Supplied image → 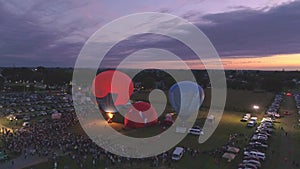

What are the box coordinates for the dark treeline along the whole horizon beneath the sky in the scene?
[0,67,300,92]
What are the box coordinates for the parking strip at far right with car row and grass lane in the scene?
[238,94,300,169]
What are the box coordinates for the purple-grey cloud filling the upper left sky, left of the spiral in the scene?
[0,0,99,66]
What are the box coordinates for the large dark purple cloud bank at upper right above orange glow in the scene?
[198,1,300,57]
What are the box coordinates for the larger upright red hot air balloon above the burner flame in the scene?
[92,70,133,106]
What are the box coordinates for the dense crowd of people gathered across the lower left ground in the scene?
[1,106,204,168]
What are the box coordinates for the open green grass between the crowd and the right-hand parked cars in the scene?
[12,90,282,169]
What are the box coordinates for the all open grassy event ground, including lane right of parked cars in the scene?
[2,91,300,169]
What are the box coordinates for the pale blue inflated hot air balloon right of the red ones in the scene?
[169,81,204,118]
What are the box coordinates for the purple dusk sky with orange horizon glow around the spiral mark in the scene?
[0,0,300,70]
